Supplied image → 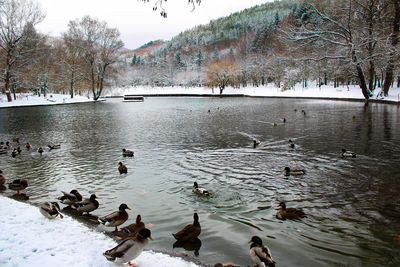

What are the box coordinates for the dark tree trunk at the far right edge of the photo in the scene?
[383,0,400,96]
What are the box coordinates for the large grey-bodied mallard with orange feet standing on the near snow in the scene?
[103,228,153,266]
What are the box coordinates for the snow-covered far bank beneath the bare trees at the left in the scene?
[0,94,94,108]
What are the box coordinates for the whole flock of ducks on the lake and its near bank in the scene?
[0,124,356,267]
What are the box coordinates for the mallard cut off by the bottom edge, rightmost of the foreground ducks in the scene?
[249,236,275,267]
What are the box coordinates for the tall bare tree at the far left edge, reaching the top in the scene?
[0,0,44,101]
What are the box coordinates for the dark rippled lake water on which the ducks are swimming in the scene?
[0,98,400,266]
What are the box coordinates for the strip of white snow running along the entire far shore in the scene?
[0,83,400,108]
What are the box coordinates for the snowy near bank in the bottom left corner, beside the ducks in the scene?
[0,196,197,267]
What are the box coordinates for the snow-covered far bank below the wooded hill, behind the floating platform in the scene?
[106,84,400,102]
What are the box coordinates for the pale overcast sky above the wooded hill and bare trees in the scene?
[37,0,271,49]
